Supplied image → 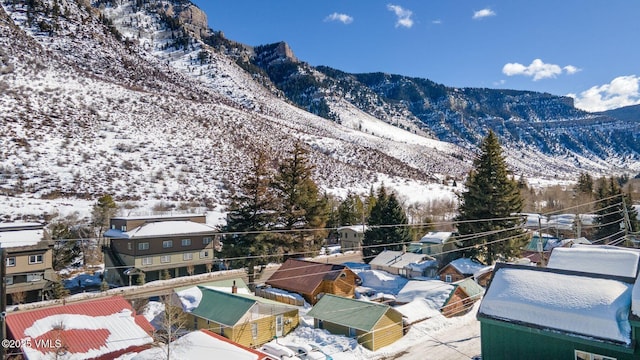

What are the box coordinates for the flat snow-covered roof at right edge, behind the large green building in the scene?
[547,245,640,278]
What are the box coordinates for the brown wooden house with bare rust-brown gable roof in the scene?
[265,259,360,304]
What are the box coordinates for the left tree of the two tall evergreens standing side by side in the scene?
[223,151,277,282]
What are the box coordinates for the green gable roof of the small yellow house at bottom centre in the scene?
[307,294,396,331]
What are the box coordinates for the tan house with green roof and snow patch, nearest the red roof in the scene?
[176,286,300,347]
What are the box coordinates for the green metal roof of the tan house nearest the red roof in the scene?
[191,286,256,326]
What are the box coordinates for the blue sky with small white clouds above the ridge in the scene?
[193,0,640,111]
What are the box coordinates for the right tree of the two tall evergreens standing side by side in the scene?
[272,143,329,253]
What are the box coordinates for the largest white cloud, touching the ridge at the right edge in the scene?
[567,75,640,111]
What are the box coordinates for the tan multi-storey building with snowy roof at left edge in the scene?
[0,222,58,304]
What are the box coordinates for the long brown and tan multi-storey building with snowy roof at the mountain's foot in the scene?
[104,214,221,283]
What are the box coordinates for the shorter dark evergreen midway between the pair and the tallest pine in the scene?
[362,186,411,263]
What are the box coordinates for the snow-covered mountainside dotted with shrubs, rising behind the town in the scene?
[0,0,640,214]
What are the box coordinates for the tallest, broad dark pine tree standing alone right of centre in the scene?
[456,131,525,263]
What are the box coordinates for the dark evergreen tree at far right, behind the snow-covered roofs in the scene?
[595,177,638,244]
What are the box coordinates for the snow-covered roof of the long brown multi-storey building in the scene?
[104,221,216,239]
